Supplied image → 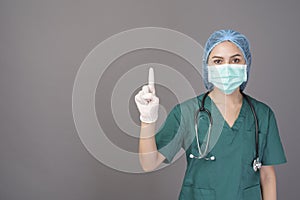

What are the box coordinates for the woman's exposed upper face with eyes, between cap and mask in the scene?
[207,41,246,66]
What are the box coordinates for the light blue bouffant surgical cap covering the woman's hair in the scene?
[202,30,251,91]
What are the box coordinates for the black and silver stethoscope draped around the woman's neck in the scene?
[190,91,262,172]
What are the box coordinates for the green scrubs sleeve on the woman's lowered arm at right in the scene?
[262,110,287,165]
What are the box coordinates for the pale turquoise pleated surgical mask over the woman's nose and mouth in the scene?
[207,64,247,94]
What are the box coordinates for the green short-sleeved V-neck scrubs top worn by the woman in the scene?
[155,94,286,200]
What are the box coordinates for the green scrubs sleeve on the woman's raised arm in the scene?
[155,104,184,163]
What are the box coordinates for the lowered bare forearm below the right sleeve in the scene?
[260,166,277,200]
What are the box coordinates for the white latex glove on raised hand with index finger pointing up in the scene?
[135,68,159,123]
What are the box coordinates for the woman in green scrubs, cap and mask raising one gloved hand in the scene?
[135,30,286,200]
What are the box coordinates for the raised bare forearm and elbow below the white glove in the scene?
[139,122,165,171]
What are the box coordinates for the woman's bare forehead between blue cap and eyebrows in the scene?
[209,41,243,58]
